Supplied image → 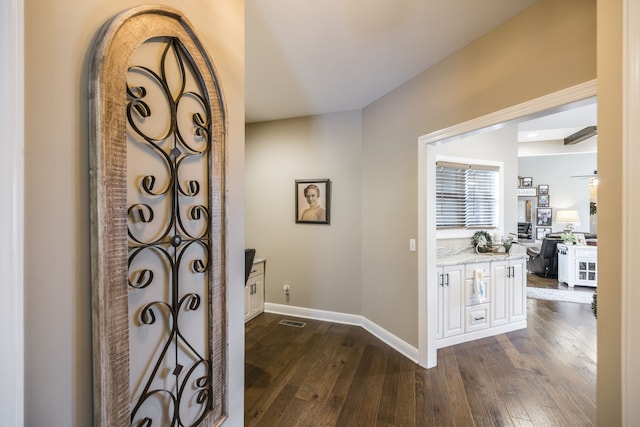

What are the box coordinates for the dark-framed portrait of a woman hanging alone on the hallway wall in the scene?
[295,179,331,224]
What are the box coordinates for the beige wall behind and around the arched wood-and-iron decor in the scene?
[24,0,244,426]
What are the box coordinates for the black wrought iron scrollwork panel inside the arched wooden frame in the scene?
[126,37,212,427]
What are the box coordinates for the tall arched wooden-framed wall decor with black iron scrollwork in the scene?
[89,6,228,427]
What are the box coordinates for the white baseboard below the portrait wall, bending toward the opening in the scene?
[264,302,418,363]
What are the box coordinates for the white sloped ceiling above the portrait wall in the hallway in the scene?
[245,0,536,123]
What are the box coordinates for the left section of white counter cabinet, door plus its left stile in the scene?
[437,265,465,338]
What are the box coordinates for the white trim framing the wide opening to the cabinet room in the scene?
[418,80,597,368]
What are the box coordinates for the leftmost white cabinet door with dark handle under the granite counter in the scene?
[442,265,465,338]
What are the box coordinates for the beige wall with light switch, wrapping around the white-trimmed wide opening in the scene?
[362,0,596,346]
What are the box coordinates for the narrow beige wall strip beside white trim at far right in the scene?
[598,0,624,426]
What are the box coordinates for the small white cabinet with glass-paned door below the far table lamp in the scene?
[558,244,598,287]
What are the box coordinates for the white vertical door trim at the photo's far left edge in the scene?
[0,0,24,427]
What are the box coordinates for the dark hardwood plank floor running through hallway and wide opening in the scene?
[245,299,596,427]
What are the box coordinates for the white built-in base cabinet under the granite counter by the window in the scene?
[436,255,527,348]
